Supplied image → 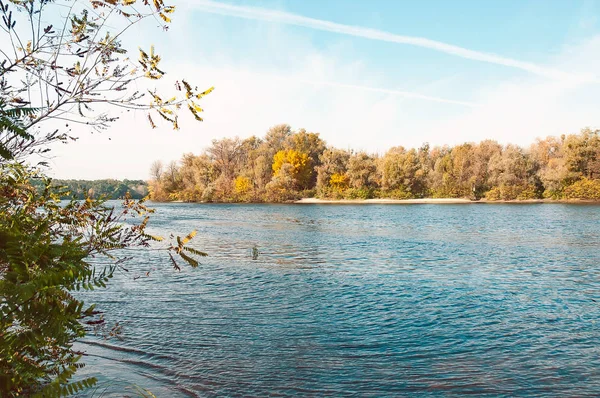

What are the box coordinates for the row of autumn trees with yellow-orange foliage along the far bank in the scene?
[149,124,600,202]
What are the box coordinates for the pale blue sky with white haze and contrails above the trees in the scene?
[50,0,600,179]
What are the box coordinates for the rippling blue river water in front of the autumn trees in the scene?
[80,204,600,397]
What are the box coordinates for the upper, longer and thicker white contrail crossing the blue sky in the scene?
[190,0,600,83]
